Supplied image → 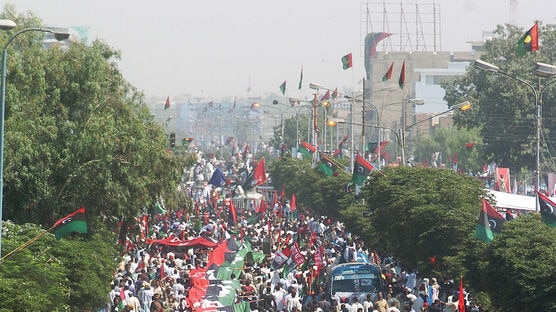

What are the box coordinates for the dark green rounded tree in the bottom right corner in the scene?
[474,213,556,312]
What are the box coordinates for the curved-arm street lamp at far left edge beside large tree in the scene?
[0,20,69,257]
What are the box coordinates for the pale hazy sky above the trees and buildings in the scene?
[7,0,556,98]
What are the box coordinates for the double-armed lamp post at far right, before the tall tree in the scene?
[473,60,556,212]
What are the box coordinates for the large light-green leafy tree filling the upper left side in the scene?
[0,8,186,234]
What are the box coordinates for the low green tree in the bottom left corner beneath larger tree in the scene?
[0,221,118,312]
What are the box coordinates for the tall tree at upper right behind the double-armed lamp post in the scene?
[444,21,556,177]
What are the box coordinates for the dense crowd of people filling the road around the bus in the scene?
[106,154,481,312]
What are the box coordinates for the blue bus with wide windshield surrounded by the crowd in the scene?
[327,262,385,304]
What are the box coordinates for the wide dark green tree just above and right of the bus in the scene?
[363,167,485,277]
